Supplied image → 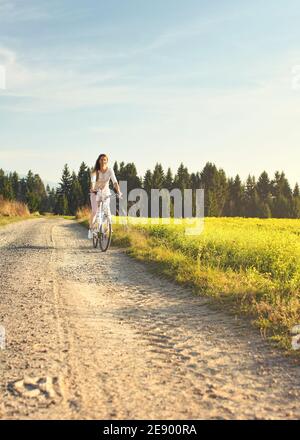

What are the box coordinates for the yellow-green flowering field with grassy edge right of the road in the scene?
[113,218,300,348]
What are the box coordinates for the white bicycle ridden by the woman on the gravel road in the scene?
[91,190,121,252]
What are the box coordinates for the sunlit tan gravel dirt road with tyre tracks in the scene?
[0,219,300,419]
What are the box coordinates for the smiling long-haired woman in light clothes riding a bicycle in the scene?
[88,154,122,238]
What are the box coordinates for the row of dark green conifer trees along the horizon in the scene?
[0,162,300,218]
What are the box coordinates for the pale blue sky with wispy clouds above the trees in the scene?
[0,0,300,185]
